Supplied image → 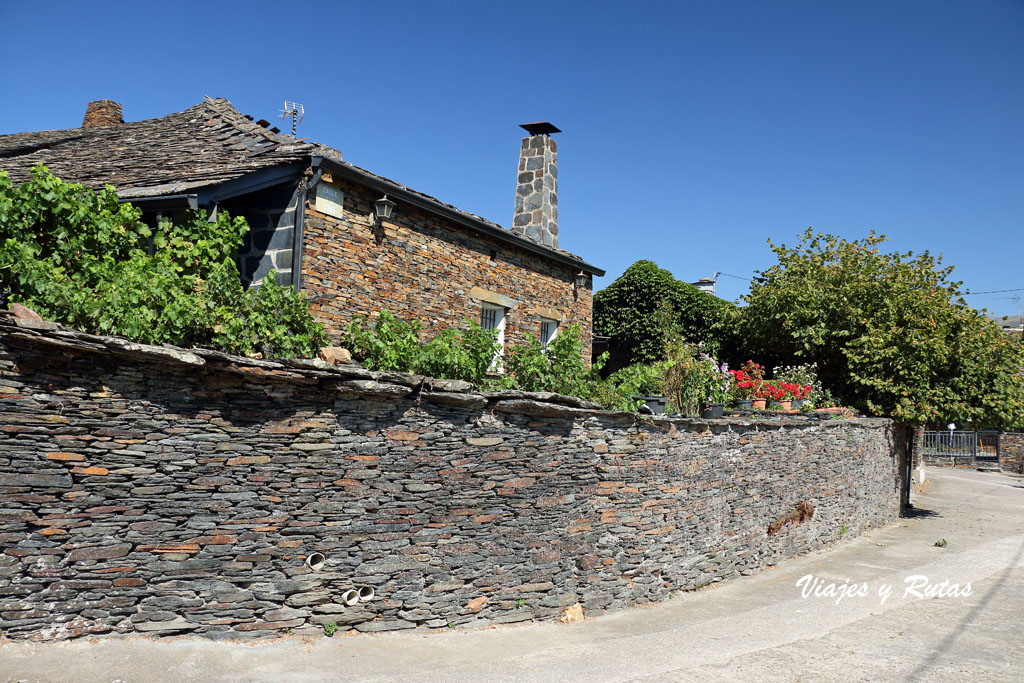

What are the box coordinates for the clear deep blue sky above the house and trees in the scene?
[0,0,1024,313]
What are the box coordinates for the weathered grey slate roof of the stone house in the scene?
[0,97,604,275]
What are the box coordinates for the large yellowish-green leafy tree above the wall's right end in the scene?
[740,228,1024,426]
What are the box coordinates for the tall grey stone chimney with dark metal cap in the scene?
[512,122,561,249]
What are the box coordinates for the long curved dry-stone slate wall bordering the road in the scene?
[0,314,906,639]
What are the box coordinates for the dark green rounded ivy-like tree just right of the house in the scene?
[594,261,736,370]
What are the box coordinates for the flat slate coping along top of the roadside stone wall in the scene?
[0,310,892,431]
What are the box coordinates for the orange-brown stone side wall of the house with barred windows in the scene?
[302,180,593,360]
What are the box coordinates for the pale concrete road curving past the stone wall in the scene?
[0,469,1024,683]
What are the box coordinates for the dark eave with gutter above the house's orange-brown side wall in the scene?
[312,156,605,278]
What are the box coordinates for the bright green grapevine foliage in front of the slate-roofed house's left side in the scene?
[0,166,327,356]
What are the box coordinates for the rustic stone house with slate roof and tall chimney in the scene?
[0,97,604,359]
